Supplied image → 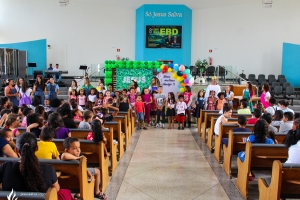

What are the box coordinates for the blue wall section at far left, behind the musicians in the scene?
[0,39,47,75]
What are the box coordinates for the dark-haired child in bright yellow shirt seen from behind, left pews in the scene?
[35,126,60,160]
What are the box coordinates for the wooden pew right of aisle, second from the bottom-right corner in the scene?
[236,142,288,199]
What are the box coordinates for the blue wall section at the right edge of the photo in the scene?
[281,43,300,87]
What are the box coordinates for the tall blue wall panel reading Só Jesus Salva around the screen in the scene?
[135,4,192,66]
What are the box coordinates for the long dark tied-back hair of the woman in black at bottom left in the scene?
[16,133,46,192]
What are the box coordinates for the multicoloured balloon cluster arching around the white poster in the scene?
[156,63,194,93]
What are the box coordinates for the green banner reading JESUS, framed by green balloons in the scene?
[116,68,153,90]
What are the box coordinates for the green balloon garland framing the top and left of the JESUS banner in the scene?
[105,60,162,85]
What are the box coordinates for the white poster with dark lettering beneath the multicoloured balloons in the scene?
[156,72,179,98]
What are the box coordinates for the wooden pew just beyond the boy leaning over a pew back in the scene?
[53,139,109,192]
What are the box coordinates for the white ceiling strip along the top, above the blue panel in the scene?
[92,0,262,10]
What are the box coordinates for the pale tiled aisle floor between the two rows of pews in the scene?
[112,128,229,200]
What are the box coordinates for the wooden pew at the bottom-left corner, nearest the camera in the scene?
[0,187,58,200]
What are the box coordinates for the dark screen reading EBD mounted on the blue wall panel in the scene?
[146,26,182,48]
